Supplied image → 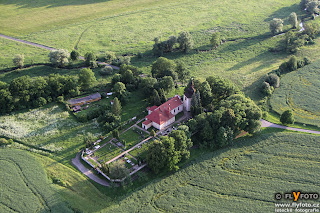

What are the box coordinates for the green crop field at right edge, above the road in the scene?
[270,61,320,127]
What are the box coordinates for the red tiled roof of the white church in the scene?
[146,96,183,125]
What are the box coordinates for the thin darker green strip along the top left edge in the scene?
[1,0,110,8]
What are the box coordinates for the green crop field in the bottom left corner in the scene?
[0,148,73,212]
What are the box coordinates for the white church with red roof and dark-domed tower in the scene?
[142,83,195,130]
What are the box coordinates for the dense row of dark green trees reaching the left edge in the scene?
[0,68,96,113]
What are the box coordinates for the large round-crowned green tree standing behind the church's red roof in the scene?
[151,57,176,78]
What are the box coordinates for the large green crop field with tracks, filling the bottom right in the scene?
[106,133,320,212]
